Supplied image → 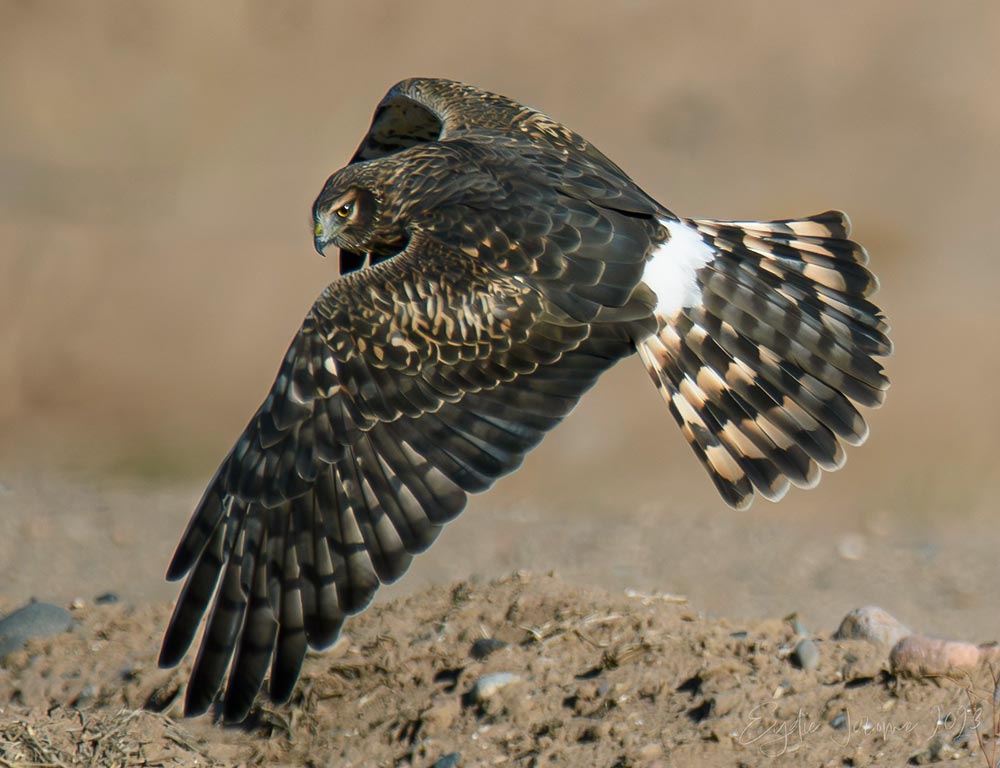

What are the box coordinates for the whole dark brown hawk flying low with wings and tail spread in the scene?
[160,79,891,721]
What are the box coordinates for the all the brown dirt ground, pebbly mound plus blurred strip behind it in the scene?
[0,474,996,768]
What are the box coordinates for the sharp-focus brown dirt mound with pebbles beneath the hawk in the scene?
[0,574,993,768]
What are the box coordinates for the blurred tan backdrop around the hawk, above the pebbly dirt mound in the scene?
[0,0,1000,639]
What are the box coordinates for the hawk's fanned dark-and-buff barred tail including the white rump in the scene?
[639,211,892,509]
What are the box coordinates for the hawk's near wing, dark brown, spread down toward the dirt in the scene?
[160,220,654,720]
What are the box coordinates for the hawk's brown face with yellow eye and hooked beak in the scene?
[313,166,379,254]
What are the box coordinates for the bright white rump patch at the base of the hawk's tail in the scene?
[643,220,717,318]
